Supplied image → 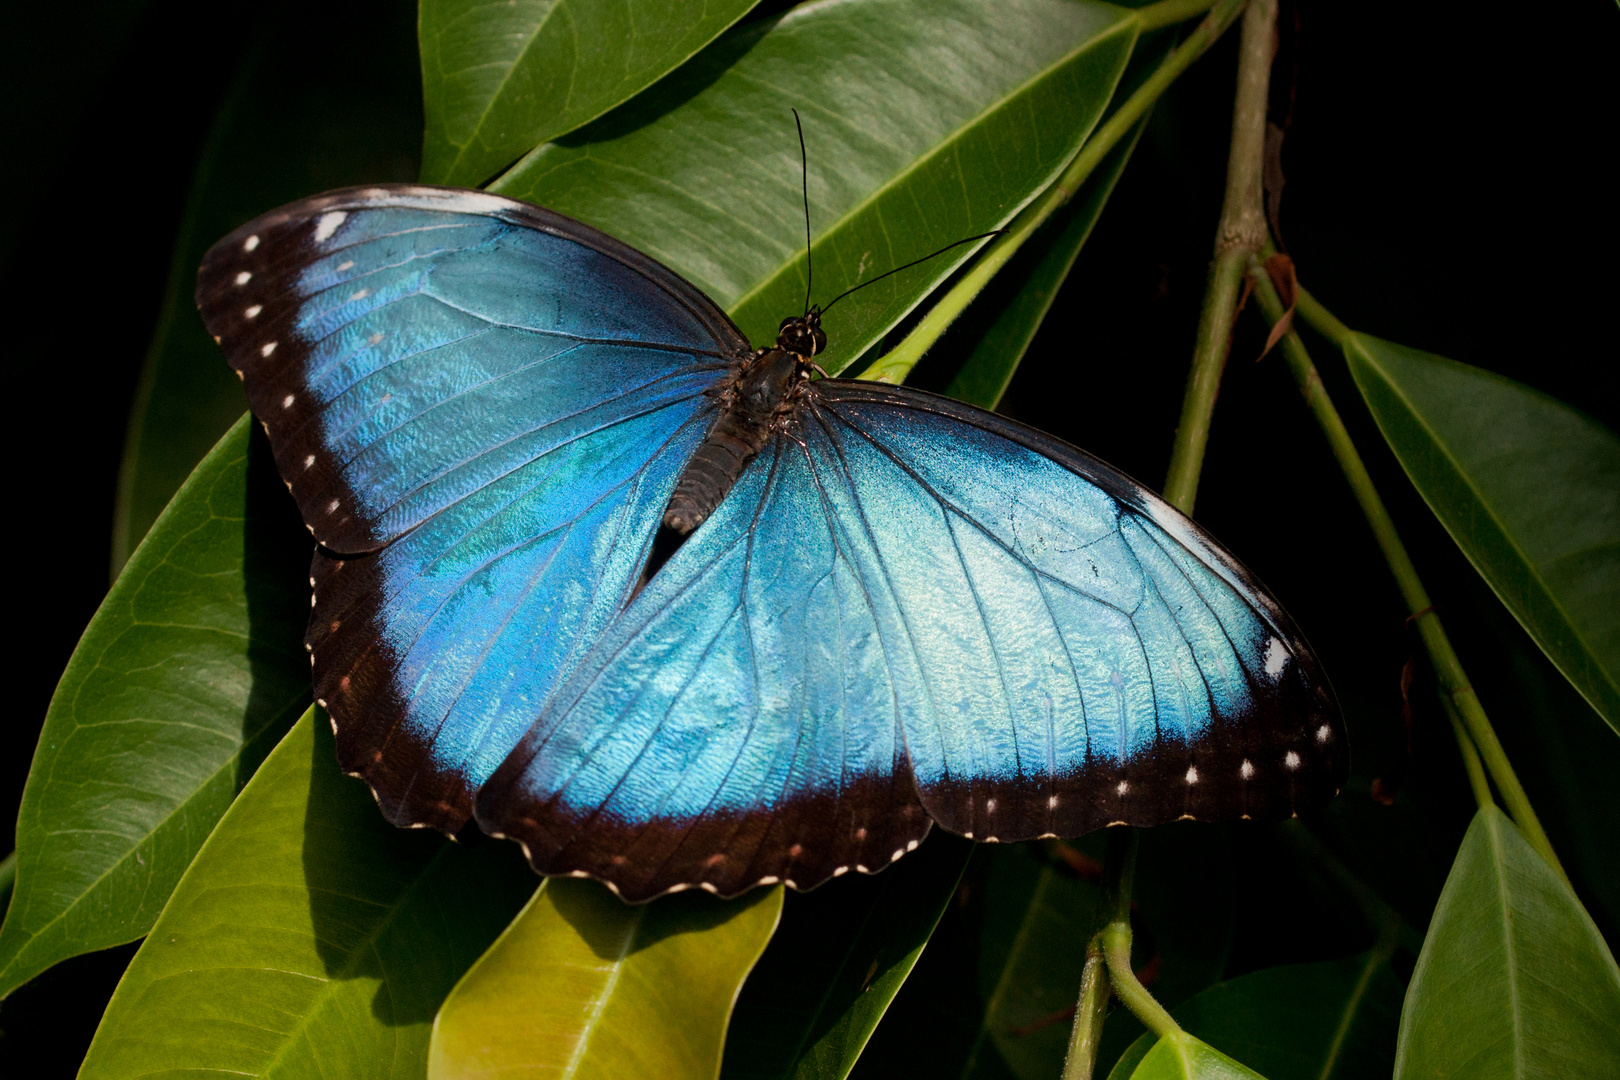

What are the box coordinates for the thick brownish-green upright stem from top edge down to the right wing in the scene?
[1165,0,1277,517]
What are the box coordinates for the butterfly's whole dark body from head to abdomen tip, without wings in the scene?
[664,309,826,536]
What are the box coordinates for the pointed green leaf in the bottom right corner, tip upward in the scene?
[1395,806,1620,1080]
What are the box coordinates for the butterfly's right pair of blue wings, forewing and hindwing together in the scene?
[478,381,1346,899]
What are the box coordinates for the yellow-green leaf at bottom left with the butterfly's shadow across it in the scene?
[79,709,535,1080]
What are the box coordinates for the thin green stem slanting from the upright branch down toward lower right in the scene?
[1252,266,1568,881]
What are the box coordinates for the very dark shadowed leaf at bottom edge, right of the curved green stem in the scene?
[1108,952,1401,1080]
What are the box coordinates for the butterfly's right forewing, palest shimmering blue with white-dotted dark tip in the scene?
[821,381,1348,840]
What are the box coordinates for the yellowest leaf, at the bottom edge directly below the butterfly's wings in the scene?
[428,878,782,1080]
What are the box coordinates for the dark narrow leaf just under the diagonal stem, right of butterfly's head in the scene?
[941,111,1147,410]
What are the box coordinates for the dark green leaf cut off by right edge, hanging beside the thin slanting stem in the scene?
[1345,334,1620,732]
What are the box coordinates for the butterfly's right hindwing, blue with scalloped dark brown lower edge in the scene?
[478,440,928,900]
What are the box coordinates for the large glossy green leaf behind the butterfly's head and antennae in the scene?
[492,0,1137,371]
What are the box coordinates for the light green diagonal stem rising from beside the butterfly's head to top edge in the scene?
[859,0,1246,384]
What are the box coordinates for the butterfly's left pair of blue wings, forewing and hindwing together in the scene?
[198,186,748,832]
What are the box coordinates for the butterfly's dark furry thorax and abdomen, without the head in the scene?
[664,348,805,536]
